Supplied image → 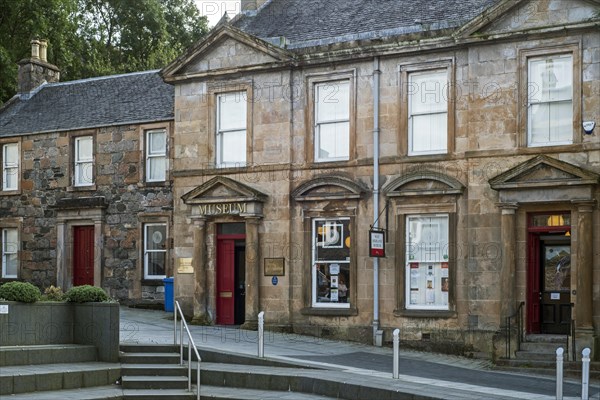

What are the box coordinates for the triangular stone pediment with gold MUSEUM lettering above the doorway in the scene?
[181,176,267,217]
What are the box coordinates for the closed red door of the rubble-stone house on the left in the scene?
[73,226,94,286]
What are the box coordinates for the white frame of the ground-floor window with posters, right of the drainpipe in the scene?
[404,213,453,311]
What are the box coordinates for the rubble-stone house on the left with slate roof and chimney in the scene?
[0,40,174,303]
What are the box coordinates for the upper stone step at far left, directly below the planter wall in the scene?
[0,344,97,367]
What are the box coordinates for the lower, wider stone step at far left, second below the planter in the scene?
[0,361,121,396]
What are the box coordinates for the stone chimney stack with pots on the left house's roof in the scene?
[18,39,60,97]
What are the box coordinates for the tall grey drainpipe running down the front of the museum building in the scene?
[373,57,382,346]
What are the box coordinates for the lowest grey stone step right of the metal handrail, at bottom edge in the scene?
[200,385,336,400]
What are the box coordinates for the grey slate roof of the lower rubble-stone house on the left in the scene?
[0,70,175,137]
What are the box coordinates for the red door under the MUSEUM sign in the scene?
[217,239,235,325]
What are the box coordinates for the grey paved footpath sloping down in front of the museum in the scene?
[120,307,600,400]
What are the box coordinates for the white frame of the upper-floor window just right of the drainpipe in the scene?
[408,68,450,156]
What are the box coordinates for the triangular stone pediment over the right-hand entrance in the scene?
[489,155,600,203]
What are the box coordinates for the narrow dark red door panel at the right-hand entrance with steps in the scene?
[527,233,541,333]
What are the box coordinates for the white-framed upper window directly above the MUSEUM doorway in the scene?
[217,91,247,167]
